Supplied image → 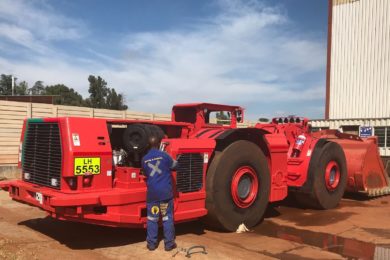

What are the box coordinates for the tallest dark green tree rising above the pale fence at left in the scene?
[87,75,109,108]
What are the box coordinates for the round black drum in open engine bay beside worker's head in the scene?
[123,124,151,153]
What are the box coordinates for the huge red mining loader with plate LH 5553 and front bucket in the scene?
[0,103,389,231]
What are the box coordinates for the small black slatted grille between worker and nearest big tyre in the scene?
[176,153,203,193]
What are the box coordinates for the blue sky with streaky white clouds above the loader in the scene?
[0,0,327,119]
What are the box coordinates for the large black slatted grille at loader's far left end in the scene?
[23,122,62,189]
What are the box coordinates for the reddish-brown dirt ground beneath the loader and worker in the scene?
[0,191,390,260]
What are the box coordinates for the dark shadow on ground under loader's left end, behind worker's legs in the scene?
[19,217,204,249]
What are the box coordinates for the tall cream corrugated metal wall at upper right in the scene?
[329,0,390,119]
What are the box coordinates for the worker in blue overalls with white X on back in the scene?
[142,136,176,251]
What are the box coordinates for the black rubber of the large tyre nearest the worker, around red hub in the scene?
[205,141,270,231]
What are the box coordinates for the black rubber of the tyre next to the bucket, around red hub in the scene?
[293,142,347,209]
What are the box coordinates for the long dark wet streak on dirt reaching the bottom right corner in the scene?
[254,221,390,259]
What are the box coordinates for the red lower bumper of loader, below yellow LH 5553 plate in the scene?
[0,180,207,227]
